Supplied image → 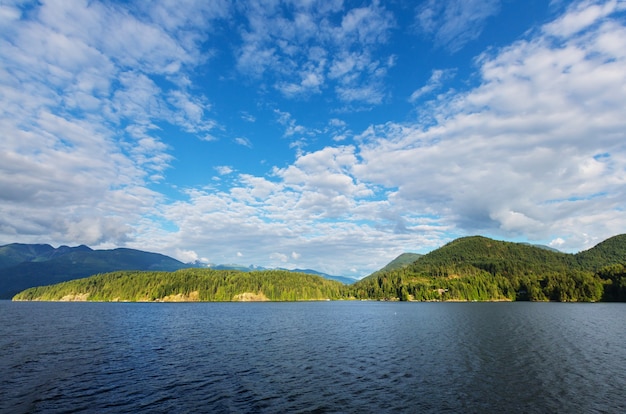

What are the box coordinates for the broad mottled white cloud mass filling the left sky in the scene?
[0,0,225,245]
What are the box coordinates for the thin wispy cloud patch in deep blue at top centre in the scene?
[236,1,394,104]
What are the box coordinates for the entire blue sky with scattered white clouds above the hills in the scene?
[0,0,626,278]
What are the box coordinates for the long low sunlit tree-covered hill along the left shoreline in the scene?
[13,268,344,301]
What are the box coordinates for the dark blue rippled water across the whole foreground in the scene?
[0,301,626,413]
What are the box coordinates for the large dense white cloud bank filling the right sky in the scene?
[354,0,626,247]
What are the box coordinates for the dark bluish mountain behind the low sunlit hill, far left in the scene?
[0,243,188,299]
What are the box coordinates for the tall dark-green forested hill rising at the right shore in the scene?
[353,235,626,301]
